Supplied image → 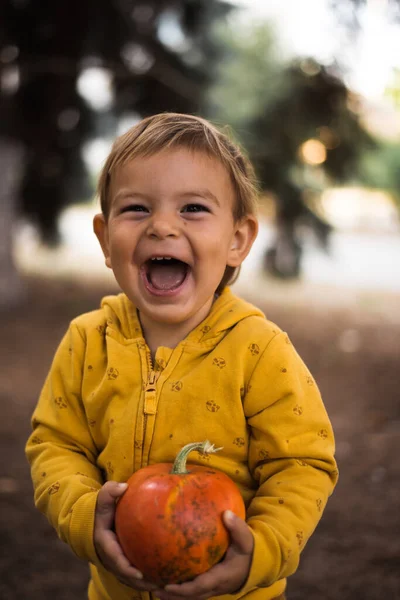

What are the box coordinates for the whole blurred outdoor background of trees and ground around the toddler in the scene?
[0,0,400,600]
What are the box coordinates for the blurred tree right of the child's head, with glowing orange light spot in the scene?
[208,24,374,278]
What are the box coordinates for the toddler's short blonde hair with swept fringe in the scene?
[97,113,258,293]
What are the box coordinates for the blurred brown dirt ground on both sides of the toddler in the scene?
[0,278,400,600]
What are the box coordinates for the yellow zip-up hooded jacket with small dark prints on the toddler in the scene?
[26,288,337,600]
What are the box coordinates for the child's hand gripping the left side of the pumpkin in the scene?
[93,481,161,591]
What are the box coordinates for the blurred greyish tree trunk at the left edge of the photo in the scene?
[0,138,24,309]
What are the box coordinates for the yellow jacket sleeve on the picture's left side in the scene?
[26,323,102,563]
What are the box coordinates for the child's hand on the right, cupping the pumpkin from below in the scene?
[155,510,254,600]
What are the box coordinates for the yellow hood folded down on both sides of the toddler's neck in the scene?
[101,287,265,342]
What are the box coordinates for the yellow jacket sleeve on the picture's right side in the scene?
[241,332,338,593]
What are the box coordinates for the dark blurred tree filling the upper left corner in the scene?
[0,0,231,303]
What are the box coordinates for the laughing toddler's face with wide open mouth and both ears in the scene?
[94,148,257,330]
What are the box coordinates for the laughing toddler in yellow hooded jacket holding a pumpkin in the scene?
[26,113,337,600]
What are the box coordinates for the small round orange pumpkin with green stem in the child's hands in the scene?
[115,441,245,586]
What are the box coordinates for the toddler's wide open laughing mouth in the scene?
[144,256,190,293]
